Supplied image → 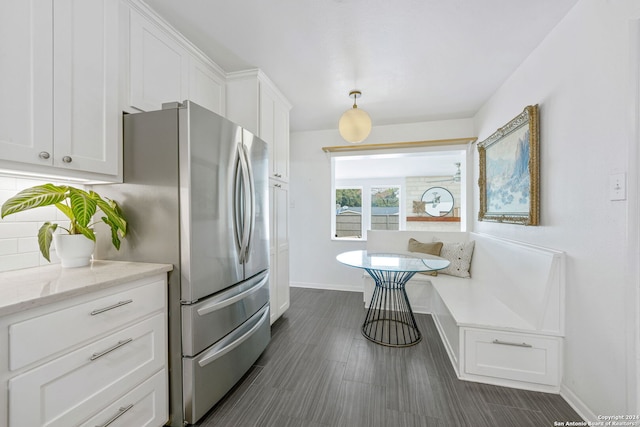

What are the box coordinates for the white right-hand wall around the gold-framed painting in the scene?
[474,0,640,421]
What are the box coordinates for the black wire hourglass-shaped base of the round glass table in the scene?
[362,269,422,347]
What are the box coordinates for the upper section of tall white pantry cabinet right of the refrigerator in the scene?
[227,70,291,181]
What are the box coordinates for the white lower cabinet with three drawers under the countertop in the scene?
[0,275,168,427]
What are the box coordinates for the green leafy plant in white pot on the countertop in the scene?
[0,184,127,267]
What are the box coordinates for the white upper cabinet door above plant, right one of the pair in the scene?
[53,0,121,175]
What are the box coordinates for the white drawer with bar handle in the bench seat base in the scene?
[464,329,561,385]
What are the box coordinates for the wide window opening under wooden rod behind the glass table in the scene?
[331,150,468,240]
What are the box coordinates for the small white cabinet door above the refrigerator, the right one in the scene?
[189,57,225,116]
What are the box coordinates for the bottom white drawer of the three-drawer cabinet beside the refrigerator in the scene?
[80,369,169,427]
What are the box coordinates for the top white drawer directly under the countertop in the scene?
[9,280,166,371]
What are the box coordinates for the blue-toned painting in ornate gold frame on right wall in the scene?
[478,105,540,225]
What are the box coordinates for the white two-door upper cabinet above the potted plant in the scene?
[0,0,121,181]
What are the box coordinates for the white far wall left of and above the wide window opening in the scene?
[289,118,474,290]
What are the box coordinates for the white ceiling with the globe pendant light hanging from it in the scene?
[146,0,578,131]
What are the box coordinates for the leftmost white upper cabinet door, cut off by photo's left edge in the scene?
[0,0,53,165]
